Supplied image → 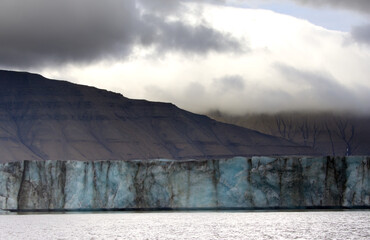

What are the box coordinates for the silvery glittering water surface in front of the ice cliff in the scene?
[0,211,370,240]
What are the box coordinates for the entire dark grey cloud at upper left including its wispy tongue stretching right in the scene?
[0,0,239,67]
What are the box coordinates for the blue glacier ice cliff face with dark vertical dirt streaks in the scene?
[0,157,370,210]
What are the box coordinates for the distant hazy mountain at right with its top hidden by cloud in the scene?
[207,111,370,156]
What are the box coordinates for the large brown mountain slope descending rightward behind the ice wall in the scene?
[0,71,313,162]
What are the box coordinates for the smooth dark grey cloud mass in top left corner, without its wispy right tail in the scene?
[0,0,139,66]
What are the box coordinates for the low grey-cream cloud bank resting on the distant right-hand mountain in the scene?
[146,63,370,115]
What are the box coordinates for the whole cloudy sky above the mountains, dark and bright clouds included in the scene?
[0,0,370,115]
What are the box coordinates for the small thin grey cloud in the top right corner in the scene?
[292,0,370,14]
